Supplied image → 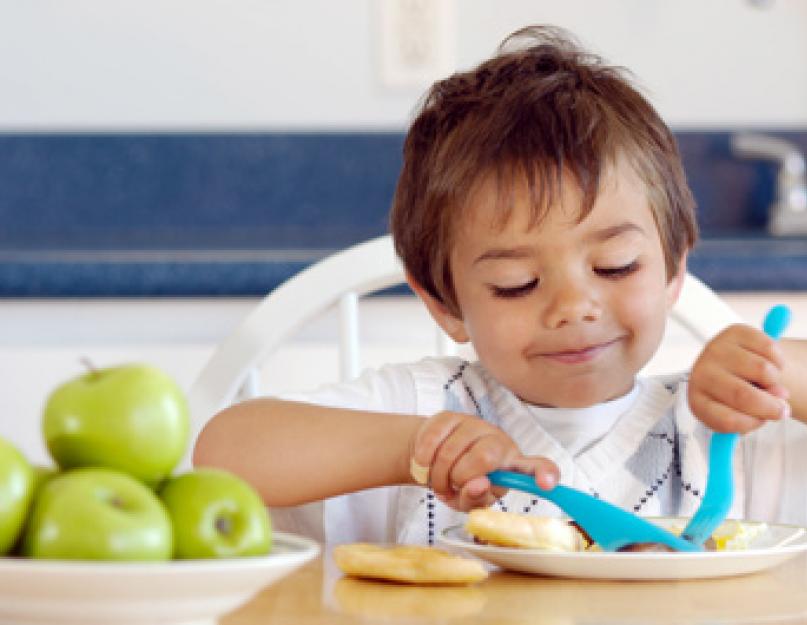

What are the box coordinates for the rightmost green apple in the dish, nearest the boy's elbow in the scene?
[160,468,272,558]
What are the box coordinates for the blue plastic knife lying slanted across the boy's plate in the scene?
[488,471,702,551]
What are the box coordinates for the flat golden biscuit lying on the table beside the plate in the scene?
[333,543,488,584]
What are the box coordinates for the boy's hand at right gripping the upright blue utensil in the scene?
[688,324,790,433]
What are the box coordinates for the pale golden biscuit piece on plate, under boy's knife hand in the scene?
[465,508,589,551]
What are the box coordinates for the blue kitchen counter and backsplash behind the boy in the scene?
[0,131,807,297]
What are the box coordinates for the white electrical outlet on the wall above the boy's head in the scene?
[375,0,457,87]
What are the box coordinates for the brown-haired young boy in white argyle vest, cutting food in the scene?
[194,27,807,544]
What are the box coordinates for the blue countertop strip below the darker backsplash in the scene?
[0,232,807,297]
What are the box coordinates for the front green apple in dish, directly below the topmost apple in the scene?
[22,467,173,560]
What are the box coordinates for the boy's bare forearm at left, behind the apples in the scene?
[193,398,423,506]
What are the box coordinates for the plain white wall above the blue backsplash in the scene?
[0,0,807,131]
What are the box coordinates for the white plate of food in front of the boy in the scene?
[440,519,807,580]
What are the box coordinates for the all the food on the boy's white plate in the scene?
[465,508,767,552]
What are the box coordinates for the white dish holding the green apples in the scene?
[0,532,319,625]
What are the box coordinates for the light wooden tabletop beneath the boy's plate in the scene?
[221,550,807,625]
